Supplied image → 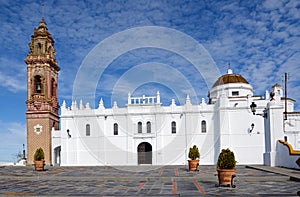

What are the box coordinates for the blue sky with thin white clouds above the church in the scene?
[0,0,300,161]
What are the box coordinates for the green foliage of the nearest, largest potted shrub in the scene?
[217,148,236,169]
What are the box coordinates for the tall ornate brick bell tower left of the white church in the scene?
[25,17,60,165]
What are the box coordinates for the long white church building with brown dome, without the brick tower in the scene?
[52,69,300,167]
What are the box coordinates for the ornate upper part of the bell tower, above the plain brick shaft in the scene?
[25,17,60,112]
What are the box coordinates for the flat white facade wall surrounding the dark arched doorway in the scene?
[61,91,265,165]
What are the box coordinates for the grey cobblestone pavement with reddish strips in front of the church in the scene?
[0,166,300,196]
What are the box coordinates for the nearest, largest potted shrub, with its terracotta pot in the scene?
[217,148,236,187]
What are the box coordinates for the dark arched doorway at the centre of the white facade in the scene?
[137,142,152,164]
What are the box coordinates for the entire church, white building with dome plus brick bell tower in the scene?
[25,19,300,168]
